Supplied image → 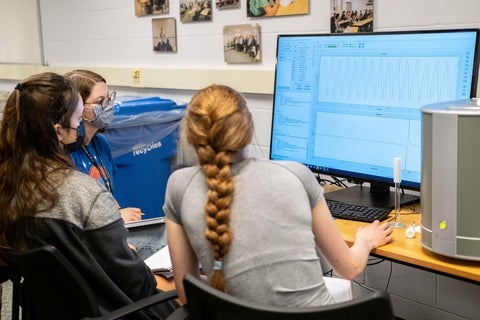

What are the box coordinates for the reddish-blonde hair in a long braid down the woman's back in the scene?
[184,85,253,292]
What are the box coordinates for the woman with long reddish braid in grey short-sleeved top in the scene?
[164,85,392,306]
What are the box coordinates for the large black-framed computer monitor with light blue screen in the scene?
[270,29,479,208]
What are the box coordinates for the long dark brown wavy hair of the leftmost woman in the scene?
[0,72,79,260]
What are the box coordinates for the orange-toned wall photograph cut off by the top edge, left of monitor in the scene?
[247,0,309,17]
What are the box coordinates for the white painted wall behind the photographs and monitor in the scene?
[0,0,480,157]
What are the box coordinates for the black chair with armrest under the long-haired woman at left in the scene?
[4,245,178,320]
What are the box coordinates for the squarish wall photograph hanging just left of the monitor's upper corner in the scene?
[223,23,261,63]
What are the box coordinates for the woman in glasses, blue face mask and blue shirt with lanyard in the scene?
[65,70,166,259]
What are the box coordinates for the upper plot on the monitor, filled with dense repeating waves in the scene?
[317,56,459,107]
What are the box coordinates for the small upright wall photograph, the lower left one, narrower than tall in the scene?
[152,18,177,52]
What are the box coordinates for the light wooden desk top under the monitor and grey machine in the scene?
[335,208,480,282]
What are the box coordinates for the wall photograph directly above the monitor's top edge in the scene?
[330,0,373,33]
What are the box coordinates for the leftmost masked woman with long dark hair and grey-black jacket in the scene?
[0,73,178,319]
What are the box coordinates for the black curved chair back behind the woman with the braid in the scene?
[183,275,394,320]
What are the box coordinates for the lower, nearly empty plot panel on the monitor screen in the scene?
[313,112,421,172]
